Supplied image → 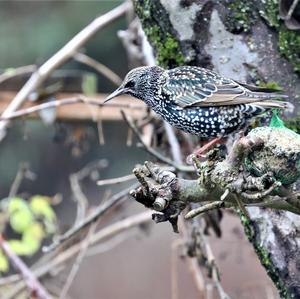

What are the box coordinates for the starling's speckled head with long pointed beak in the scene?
[105,66,164,107]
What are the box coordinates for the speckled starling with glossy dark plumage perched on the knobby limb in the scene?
[106,66,287,138]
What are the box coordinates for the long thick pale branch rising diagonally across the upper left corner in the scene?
[0,2,130,141]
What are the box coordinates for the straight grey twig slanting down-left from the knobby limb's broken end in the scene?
[44,183,139,252]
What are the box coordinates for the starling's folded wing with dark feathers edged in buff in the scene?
[163,67,284,108]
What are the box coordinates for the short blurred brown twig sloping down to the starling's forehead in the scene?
[73,53,122,86]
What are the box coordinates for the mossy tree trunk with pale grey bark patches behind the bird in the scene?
[134,0,300,298]
